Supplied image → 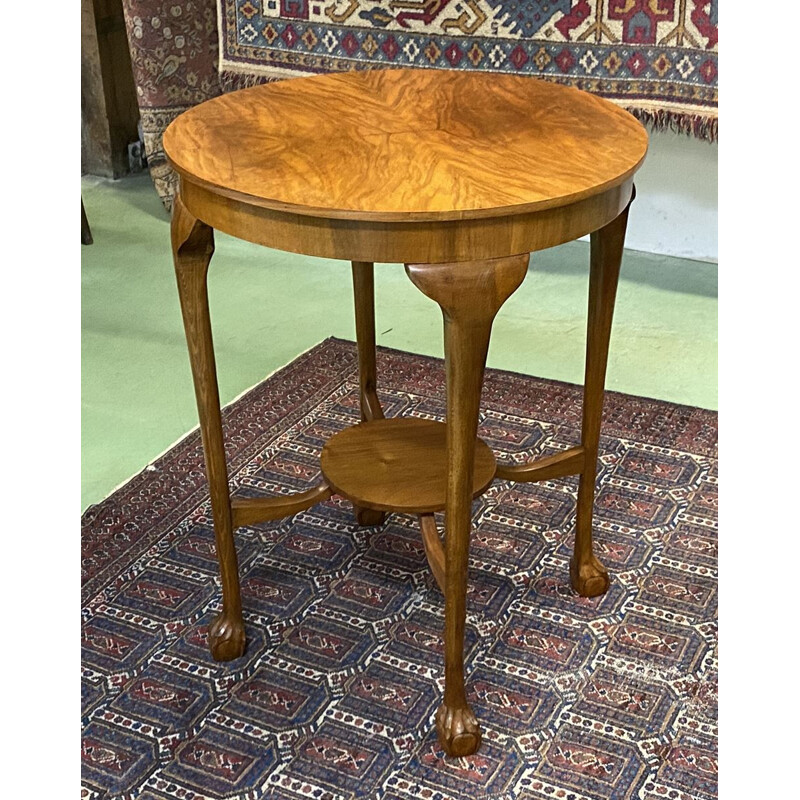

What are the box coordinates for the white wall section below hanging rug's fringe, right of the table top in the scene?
[625,130,717,261]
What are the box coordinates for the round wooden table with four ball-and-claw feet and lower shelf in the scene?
[164,70,647,755]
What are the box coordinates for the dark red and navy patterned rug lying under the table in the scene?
[82,339,717,800]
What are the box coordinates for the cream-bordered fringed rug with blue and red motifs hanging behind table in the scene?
[217,0,718,134]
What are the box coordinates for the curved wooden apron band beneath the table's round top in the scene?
[180,178,633,264]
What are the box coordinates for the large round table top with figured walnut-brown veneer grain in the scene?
[164,69,647,221]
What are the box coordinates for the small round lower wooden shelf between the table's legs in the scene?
[320,417,497,514]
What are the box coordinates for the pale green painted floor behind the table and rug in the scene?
[81,175,717,509]
